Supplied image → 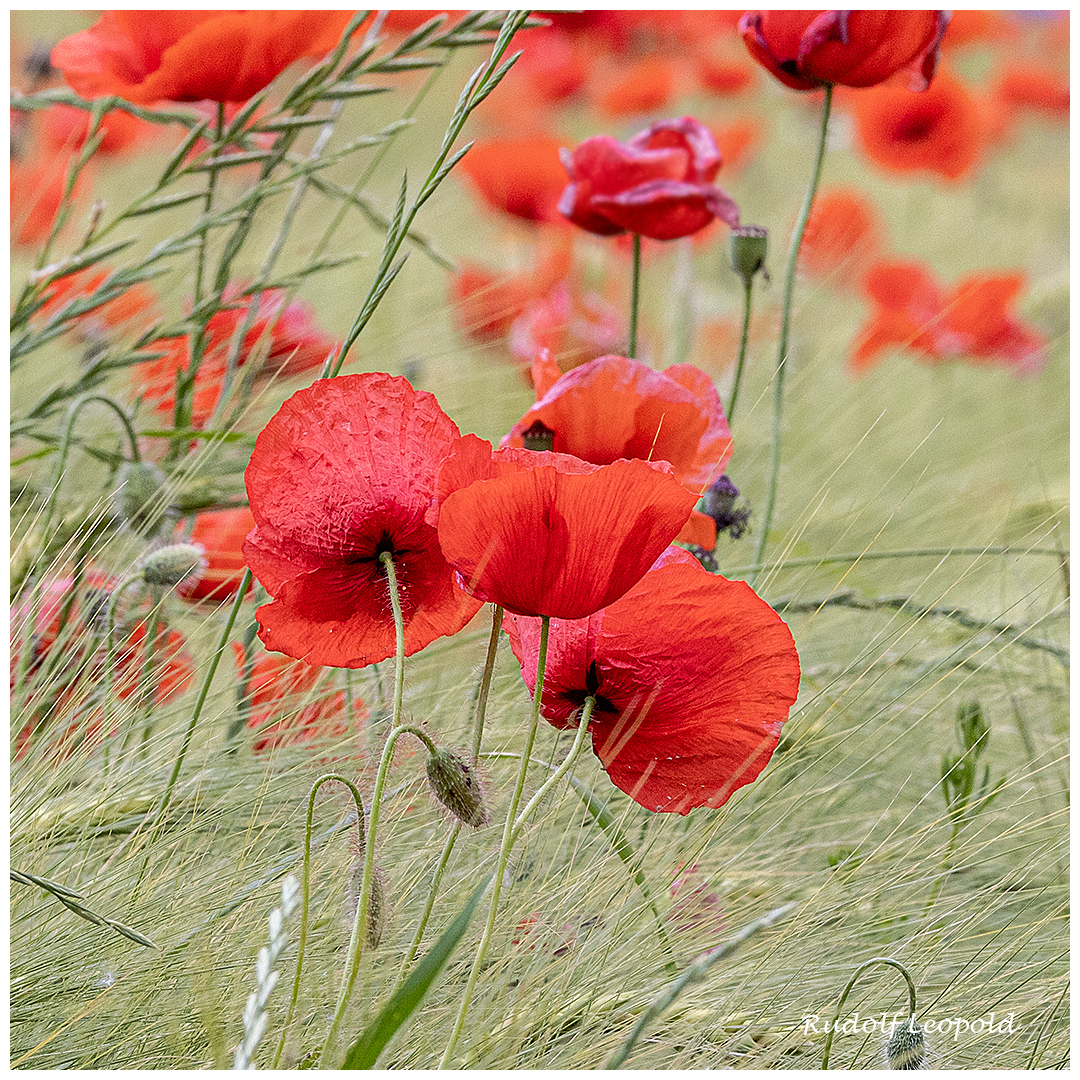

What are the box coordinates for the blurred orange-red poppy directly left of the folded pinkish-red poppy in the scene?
[458,135,566,225]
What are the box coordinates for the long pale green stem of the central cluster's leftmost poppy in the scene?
[319,551,408,1069]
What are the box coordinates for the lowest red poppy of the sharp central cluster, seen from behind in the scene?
[503,550,799,814]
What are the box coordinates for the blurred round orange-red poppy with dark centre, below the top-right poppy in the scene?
[852,75,985,180]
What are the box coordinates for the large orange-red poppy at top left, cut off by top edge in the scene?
[52,9,352,105]
